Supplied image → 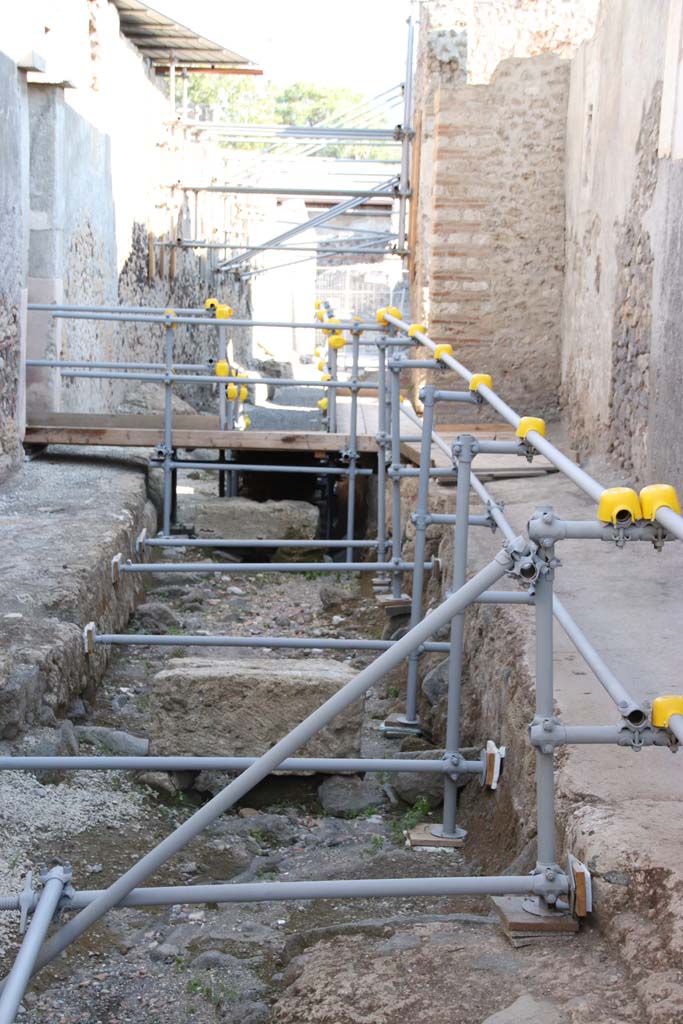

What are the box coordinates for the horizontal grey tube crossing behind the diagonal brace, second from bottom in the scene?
[0,755,482,775]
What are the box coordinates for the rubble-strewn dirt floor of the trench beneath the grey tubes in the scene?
[3,466,642,1024]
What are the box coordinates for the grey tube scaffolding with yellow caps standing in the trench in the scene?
[0,296,683,1024]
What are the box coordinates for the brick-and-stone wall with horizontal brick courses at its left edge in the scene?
[414,55,568,422]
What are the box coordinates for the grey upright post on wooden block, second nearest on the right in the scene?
[438,434,474,840]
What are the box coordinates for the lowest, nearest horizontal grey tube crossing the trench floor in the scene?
[58,874,567,913]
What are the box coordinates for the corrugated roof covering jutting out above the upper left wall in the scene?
[112,0,261,75]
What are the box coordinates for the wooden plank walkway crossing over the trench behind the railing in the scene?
[25,413,377,454]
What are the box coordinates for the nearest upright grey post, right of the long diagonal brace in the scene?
[536,567,557,869]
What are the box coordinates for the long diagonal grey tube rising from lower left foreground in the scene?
[18,551,511,969]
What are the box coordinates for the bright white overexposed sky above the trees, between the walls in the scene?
[150,0,417,94]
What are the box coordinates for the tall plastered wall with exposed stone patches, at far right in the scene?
[562,0,683,484]
